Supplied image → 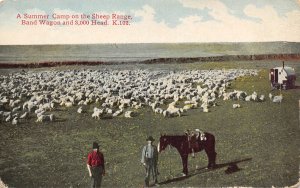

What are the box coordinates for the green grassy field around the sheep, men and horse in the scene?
[0,61,300,187]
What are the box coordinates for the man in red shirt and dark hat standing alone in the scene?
[87,142,105,188]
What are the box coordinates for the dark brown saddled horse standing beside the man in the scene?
[158,132,217,175]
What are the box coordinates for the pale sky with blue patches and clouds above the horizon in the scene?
[0,0,300,45]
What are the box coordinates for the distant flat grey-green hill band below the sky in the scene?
[0,42,300,64]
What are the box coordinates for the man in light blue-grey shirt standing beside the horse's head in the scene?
[141,136,158,187]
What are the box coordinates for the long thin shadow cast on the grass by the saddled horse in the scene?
[159,158,252,185]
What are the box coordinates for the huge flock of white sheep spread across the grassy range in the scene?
[0,69,282,124]
